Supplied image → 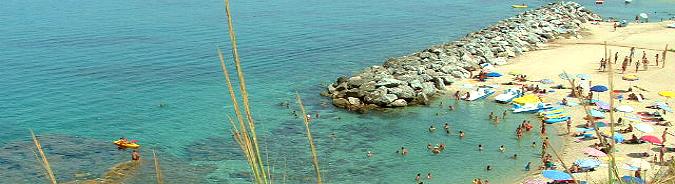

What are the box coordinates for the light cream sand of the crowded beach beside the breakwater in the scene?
[453,21,675,183]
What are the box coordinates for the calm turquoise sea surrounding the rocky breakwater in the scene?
[0,0,675,183]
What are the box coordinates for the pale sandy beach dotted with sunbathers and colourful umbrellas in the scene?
[446,21,675,183]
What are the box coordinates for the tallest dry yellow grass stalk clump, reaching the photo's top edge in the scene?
[218,0,271,181]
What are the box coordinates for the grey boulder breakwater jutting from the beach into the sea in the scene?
[322,2,599,112]
